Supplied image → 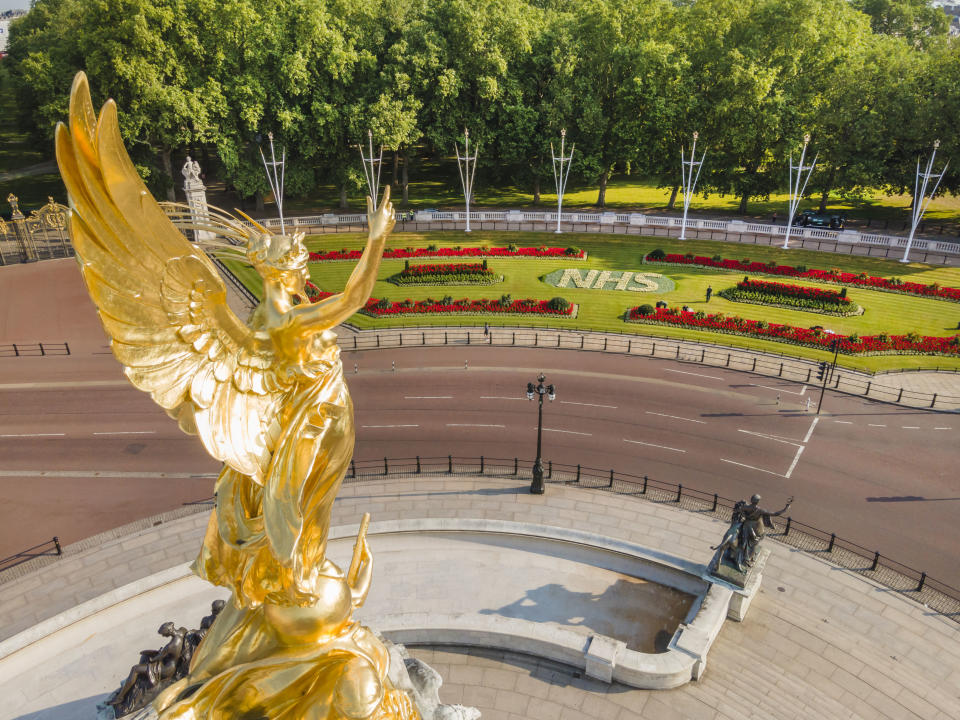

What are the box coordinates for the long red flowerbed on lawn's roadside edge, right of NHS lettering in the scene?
[626,305,960,355]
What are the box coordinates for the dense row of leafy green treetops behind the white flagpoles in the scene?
[6,0,960,211]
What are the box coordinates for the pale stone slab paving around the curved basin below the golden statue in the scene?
[0,476,960,720]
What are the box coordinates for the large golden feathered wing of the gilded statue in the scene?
[56,73,292,482]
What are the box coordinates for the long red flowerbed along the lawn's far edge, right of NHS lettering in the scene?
[643,250,960,302]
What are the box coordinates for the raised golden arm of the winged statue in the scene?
[290,185,396,330]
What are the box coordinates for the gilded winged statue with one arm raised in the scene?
[56,73,419,720]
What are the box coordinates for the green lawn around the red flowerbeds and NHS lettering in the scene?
[223,232,960,371]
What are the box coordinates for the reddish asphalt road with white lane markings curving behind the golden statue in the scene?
[0,345,960,587]
